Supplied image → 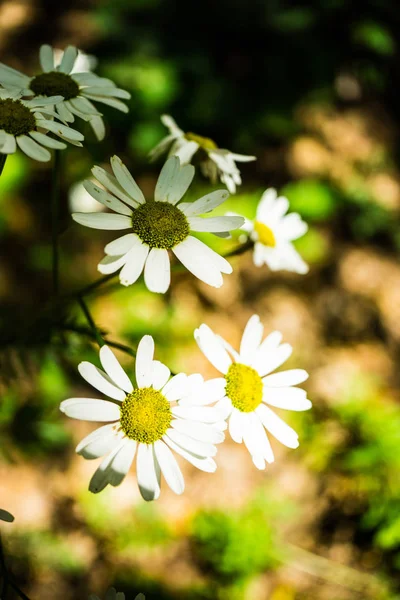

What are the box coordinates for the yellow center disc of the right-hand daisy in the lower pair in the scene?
[225,363,263,412]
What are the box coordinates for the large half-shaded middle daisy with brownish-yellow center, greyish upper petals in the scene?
[72,156,243,293]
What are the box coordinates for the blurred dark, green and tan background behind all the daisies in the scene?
[0,0,400,600]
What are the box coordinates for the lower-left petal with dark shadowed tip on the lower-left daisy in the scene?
[89,438,136,494]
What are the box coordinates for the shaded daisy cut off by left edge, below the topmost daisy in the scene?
[0,89,83,162]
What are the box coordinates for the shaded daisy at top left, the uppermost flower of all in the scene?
[0,44,131,140]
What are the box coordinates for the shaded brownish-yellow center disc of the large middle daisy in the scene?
[132,200,190,250]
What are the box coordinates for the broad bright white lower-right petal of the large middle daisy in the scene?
[172,236,232,288]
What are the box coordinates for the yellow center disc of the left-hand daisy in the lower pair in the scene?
[120,388,172,444]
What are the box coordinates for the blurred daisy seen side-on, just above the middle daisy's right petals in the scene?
[150,115,256,194]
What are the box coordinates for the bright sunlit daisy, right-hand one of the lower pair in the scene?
[195,315,311,469]
